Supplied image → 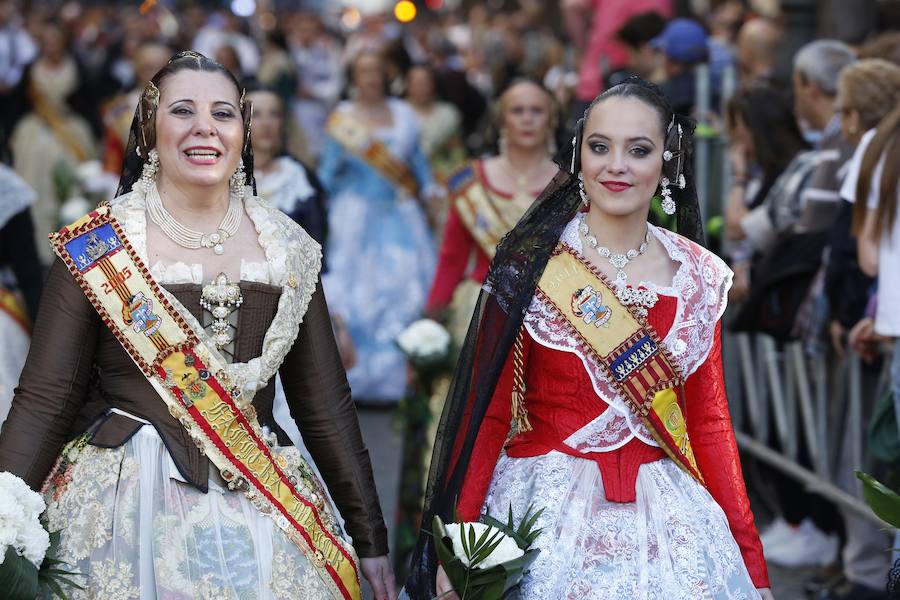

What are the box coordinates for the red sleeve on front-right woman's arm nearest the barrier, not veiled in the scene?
[684,322,769,588]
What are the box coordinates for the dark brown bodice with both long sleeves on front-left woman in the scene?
[0,260,388,557]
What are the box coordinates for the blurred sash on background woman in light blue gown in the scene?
[326,110,419,198]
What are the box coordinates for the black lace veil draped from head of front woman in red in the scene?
[405,78,703,600]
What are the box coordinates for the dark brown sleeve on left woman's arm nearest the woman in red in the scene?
[279,279,388,558]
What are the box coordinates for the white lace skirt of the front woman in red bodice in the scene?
[484,452,759,600]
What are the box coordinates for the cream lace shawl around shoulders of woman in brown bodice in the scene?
[110,185,322,405]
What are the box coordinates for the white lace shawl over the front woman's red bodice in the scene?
[524,219,733,452]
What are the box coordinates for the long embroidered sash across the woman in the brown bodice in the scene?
[50,205,360,599]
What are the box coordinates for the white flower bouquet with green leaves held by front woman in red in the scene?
[432,506,544,600]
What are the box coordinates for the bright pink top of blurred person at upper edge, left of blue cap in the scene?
[562,0,673,110]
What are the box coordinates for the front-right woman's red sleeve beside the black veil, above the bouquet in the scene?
[456,334,531,521]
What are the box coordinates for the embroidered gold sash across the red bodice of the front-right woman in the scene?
[537,243,703,484]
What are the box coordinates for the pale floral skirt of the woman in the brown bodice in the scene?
[44,426,350,600]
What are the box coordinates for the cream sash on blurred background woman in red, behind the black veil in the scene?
[447,164,528,258]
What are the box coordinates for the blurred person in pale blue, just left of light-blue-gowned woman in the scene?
[288,12,344,158]
